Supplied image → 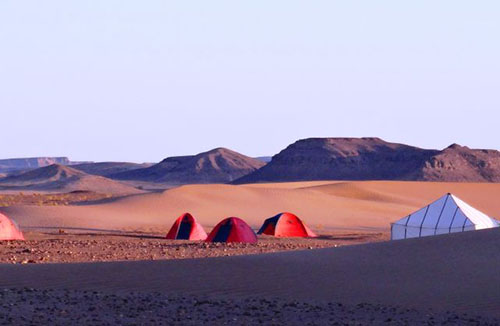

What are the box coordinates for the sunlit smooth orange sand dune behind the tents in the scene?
[3,181,500,233]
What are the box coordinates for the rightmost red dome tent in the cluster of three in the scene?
[258,213,316,237]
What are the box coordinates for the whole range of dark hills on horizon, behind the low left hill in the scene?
[0,137,500,189]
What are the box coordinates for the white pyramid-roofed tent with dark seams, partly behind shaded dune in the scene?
[391,193,500,240]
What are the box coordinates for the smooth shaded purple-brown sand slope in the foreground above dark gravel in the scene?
[0,229,500,317]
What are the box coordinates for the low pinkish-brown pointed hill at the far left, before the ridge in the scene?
[0,164,142,194]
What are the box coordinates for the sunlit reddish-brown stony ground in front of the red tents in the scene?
[0,233,387,264]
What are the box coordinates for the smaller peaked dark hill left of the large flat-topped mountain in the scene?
[110,148,265,184]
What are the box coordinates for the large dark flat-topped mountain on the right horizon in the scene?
[234,138,500,183]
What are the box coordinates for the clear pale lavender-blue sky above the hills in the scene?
[0,0,500,162]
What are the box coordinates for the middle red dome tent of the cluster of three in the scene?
[207,217,257,243]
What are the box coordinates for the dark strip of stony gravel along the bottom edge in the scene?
[0,289,500,325]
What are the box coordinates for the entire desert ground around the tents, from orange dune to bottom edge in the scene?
[0,181,500,325]
